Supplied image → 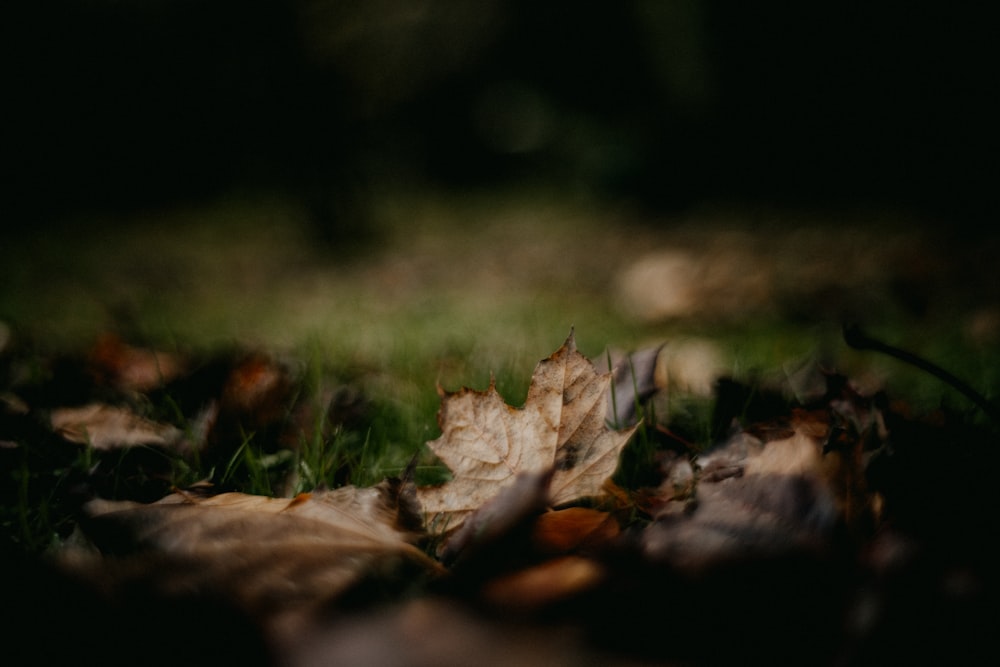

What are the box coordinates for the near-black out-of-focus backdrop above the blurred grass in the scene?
[2,0,1000,235]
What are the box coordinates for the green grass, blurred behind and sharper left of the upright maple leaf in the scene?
[0,187,1000,552]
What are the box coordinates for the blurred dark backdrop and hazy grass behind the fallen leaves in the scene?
[0,0,1000,401]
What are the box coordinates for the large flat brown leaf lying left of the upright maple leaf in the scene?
[72,481,438,632]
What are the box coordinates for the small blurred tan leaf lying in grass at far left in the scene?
[49,403,182,449]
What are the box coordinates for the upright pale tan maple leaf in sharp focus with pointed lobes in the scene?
[418,331,635,533]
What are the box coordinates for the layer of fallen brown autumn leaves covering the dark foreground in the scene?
[0,333,998,665]
